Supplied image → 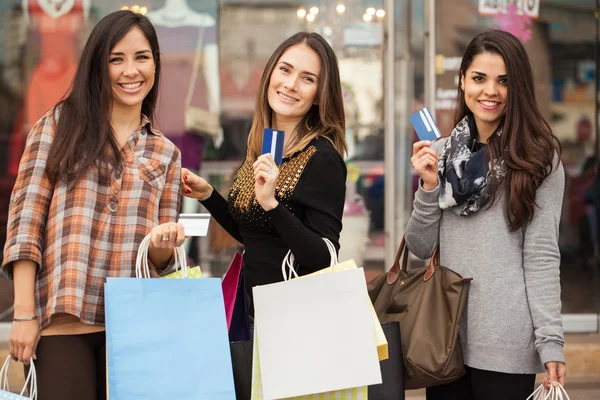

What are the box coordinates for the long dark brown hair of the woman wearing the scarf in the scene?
[455,30,561,231]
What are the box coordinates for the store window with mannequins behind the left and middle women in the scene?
[0,0,394,321]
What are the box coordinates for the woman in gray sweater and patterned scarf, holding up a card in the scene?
[406,30,566,400]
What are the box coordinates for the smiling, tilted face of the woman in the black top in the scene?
[267,43,321,122]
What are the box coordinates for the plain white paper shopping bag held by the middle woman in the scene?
[253,268,382,399]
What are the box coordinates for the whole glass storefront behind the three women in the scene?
[0,0,600,329]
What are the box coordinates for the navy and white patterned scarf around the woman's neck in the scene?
[438,116,506,216]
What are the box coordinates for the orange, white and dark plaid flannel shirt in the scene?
[2,110,181,329]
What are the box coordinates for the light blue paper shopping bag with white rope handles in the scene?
[105,236,235,400]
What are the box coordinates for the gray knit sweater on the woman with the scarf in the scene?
[405,139,565,374]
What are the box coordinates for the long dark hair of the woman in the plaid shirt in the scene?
[46,11,160,184]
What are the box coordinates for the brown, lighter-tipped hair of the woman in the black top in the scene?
[247,32,348,160]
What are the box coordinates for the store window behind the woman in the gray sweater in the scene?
[436,0,600,322]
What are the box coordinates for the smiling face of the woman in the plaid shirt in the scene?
[108,27,155,110]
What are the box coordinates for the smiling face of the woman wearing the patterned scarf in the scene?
[461,53,508,136]
